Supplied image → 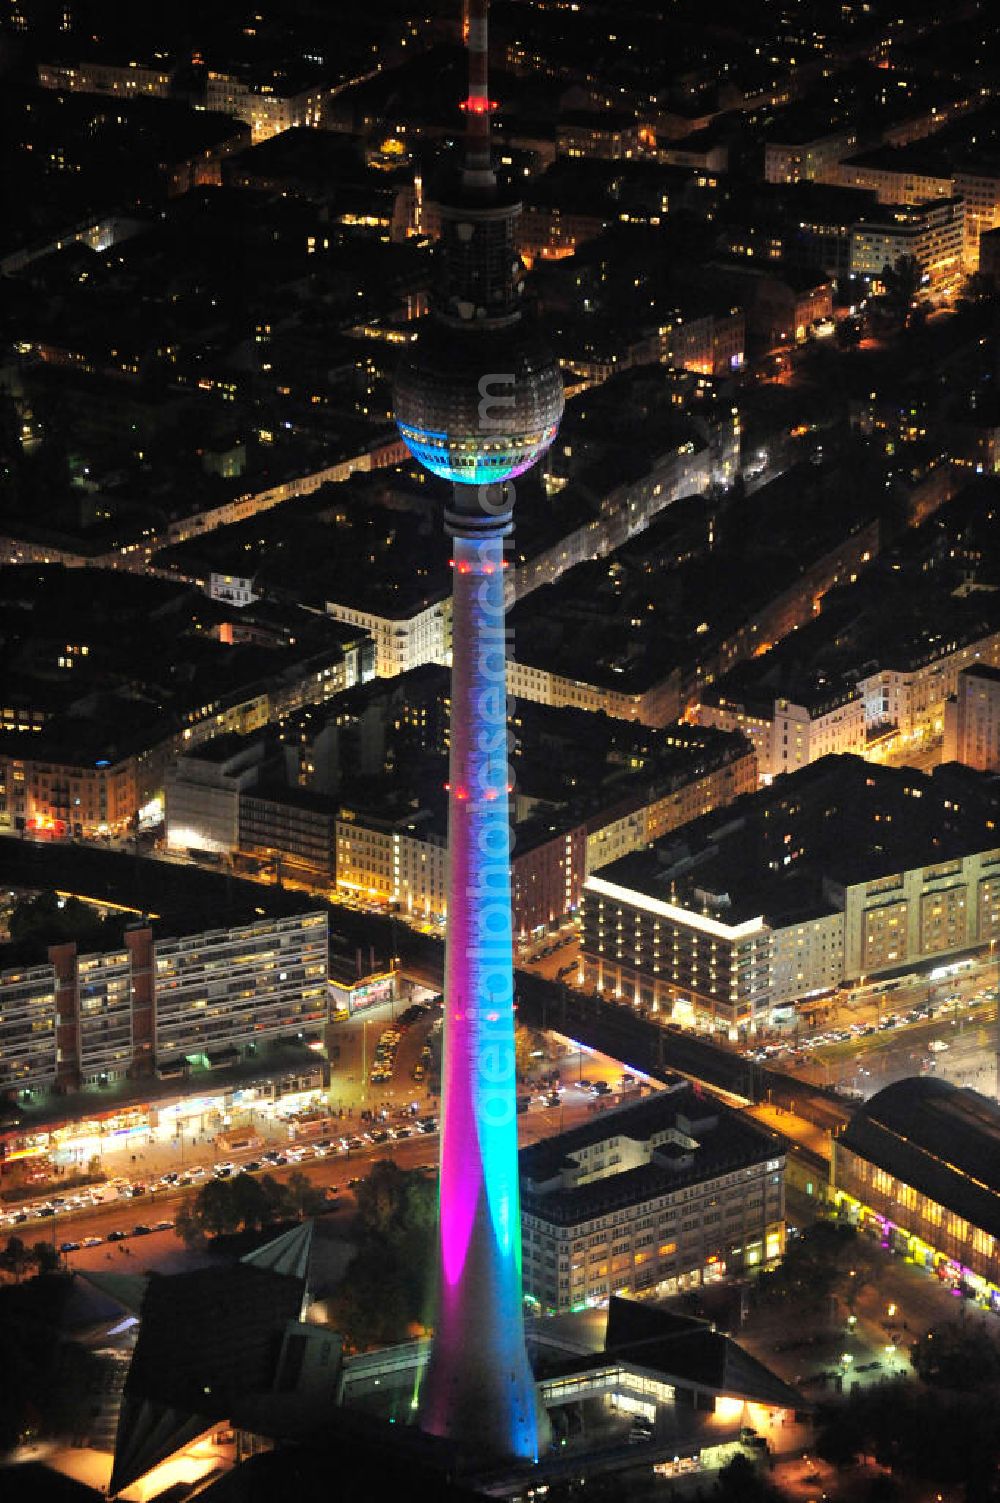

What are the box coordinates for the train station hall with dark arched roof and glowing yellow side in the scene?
[832,1076,1000,1311]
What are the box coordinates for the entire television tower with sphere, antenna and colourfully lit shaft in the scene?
[395,0,564,1459]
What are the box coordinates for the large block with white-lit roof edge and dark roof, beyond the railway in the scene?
[580,756,1000,1036]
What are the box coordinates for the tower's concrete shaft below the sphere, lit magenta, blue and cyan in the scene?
[420,511,538,1459]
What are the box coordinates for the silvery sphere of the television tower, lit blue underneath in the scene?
[395,316,564,485]
